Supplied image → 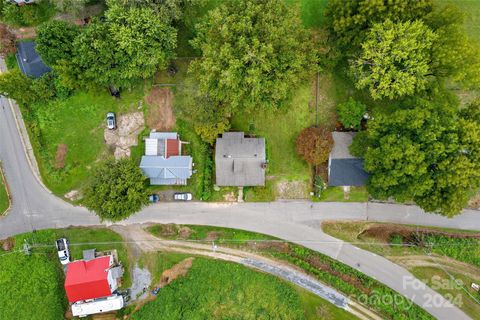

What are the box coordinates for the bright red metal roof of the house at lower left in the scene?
[65,256,112,302]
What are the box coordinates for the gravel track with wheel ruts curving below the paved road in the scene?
[111,224,380,319]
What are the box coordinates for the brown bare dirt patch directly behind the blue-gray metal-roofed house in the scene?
[145,87,175,131]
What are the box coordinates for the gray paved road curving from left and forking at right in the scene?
[0,66,480,319]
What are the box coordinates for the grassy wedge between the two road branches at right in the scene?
[322,222,480,319]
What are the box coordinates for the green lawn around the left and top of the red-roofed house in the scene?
[0,228,130,320]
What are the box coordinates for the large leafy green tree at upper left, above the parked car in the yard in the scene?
[73,1,176,87]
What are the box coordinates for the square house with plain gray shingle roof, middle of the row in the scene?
[215,132,267,187]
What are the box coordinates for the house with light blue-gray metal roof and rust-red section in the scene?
[140,132,193,185]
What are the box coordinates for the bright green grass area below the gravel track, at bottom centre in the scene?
[131,257,351,320]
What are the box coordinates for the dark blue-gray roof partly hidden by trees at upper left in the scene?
[16,41,52,78]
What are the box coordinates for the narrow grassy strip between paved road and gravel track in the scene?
[148,225,431,319]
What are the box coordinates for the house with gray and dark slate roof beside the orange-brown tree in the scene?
[328,132,368,187]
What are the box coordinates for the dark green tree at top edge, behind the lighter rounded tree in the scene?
[325,0,433,51]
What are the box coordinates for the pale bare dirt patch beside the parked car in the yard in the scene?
[103,112,145,159]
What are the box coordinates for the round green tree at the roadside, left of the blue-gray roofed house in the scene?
[84,159,148,221]
